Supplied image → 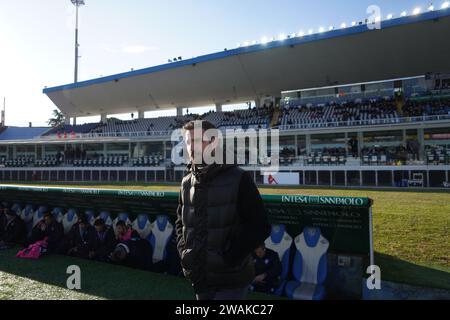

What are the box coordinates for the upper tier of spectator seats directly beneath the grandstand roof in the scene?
[4,98,450,140]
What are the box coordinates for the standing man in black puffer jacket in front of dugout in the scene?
[176,121,270,300]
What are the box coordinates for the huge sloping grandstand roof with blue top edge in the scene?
[44,9,450,117]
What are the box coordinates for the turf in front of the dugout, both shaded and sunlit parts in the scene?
[0,248,274,300]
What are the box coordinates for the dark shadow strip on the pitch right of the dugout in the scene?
[375,252,450,290]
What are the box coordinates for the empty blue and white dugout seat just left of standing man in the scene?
[149,215,173,263]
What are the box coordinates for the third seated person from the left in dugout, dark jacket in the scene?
[60,216,95,259]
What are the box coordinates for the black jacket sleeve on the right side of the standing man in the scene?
[224,172,270,265]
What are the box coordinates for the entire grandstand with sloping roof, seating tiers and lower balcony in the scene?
[0,9,450,188]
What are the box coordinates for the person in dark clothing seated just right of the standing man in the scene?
[252,244,282,293]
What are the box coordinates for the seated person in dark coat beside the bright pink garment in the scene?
[26,212,64,253]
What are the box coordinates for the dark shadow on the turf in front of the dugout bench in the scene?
[0,248,274,300]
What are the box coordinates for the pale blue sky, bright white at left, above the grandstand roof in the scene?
[0,0,444,126]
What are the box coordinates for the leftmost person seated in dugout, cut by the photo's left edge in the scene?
[0,208,26,250]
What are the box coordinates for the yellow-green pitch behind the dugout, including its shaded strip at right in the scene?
[0,184,450,290]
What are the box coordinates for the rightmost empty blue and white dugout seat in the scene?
[286,227,329,300]
